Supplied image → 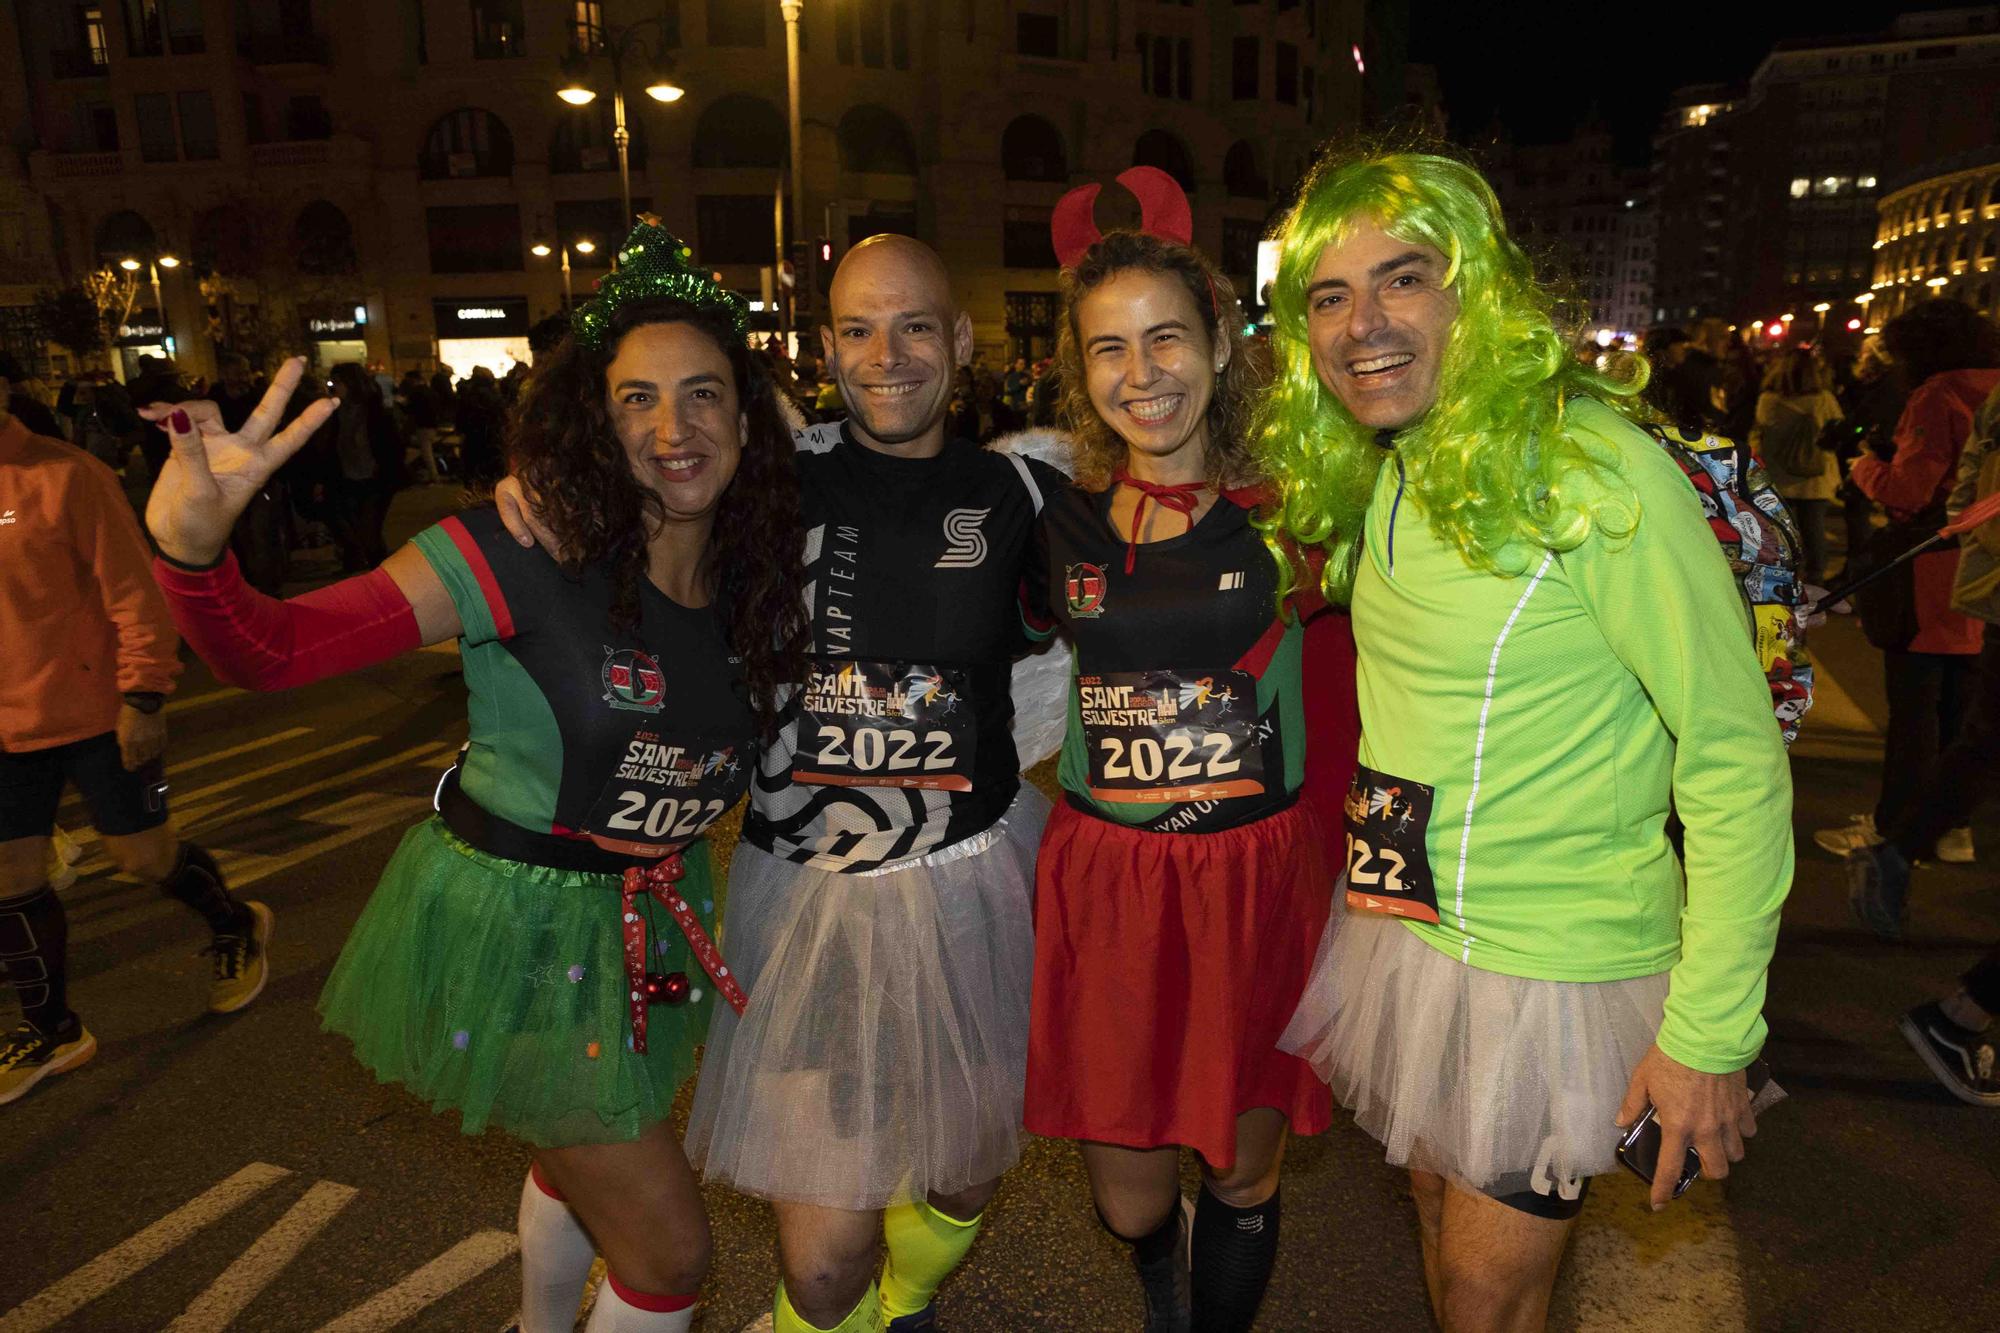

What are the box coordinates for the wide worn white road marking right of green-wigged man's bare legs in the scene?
[1564,1171,1750,1333]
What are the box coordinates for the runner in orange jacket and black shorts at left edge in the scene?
[0,366,272,1105]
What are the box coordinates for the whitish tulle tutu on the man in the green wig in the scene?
[1278,909,1668,1195]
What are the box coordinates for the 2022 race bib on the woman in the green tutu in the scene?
[578,723,750,861]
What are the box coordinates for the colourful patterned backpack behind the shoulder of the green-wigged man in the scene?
[1646,424,1812,745]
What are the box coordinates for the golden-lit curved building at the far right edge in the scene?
[1864,146,2000,324]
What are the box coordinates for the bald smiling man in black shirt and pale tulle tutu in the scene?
[688,236,1066,1333]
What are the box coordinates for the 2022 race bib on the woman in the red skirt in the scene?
[1076,671,1264,805]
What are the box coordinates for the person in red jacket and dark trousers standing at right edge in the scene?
[1812,300,2000,863]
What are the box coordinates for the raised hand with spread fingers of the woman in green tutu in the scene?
[138,356,338,564]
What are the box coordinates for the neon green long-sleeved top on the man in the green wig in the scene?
[1350,400,1792,1073]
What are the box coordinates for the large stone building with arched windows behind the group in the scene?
[0,0,1366,372]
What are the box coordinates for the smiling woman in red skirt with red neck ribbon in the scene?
[1026,192,1354,1331]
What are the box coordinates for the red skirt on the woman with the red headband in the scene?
[1024,801,1334,1169]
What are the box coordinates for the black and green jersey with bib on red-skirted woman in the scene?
[1042,486,1318,833]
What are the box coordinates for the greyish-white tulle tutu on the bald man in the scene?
[688,785,1048,1209]
